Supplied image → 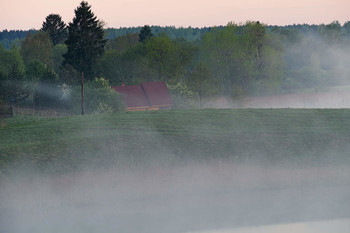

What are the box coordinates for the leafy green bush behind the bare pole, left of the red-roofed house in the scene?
[68,78,125,114]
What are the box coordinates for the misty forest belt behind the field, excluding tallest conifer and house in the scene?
[0,2,350,112]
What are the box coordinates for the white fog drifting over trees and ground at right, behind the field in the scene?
[205,25,350,108]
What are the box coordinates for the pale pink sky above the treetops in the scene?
[0,0,350,30]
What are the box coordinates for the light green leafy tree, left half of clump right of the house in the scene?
[202,23,254,96]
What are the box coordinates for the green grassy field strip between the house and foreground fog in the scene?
[0,109,350,173]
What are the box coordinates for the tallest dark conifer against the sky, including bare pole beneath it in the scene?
[63,1,107,115]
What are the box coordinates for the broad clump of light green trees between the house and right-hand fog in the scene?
[201,22,284,98]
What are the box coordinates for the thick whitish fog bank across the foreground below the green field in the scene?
[0,157,350,233]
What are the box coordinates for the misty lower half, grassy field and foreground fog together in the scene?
[0,109,350,233]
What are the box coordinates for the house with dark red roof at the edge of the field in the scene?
[112,82,174,111]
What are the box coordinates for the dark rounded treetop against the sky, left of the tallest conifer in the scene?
[41,14,67,45]
